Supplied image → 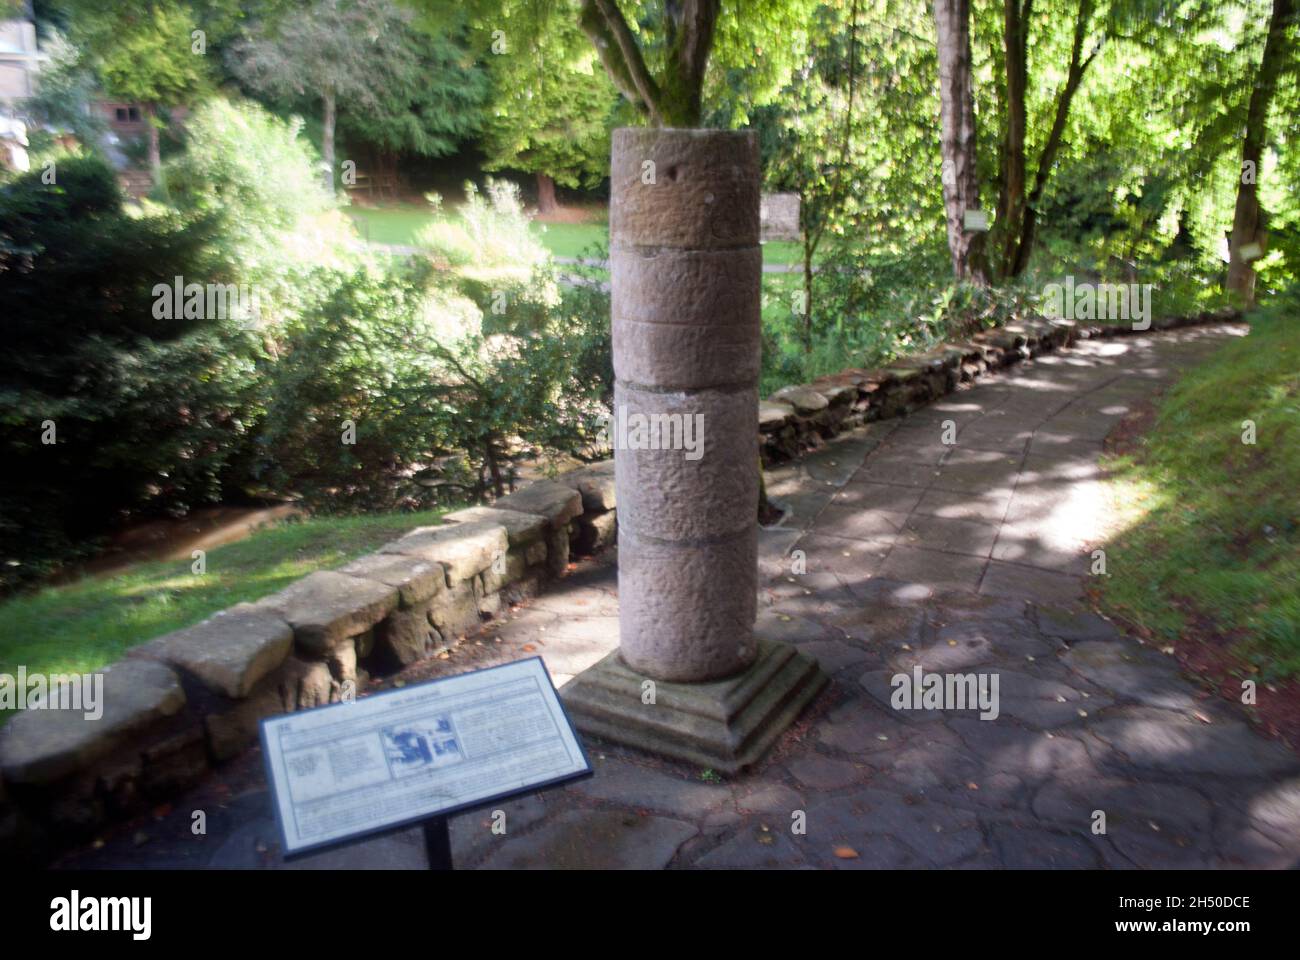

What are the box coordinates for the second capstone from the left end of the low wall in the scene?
[127,604,294,700]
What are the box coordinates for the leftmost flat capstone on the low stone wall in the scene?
[0,660,186,784]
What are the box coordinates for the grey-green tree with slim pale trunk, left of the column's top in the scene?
[230,0,431,190]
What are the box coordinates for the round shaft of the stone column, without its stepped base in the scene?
[610,129,763,682]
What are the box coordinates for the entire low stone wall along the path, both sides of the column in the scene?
[0,304,1239,856]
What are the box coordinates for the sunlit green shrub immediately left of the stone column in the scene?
[259,251,610,511]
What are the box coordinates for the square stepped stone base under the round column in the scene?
[560,640,828,774]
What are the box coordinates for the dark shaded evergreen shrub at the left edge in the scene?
[0,157,263,585]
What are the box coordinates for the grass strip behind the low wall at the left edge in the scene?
[0,510,446,697]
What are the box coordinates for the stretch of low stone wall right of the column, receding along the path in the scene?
[758,310,1240,466]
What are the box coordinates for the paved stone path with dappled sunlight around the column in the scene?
[69,327,1300,868]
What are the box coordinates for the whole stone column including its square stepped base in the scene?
[563,129,826,773]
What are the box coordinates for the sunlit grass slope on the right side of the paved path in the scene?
[1100,302,1300,680]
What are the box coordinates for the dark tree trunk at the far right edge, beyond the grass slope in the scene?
[1227,0,1295,304]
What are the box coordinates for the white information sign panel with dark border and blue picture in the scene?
[261,657,592,853]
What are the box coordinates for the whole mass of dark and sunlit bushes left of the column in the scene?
[0,100,610,585]
